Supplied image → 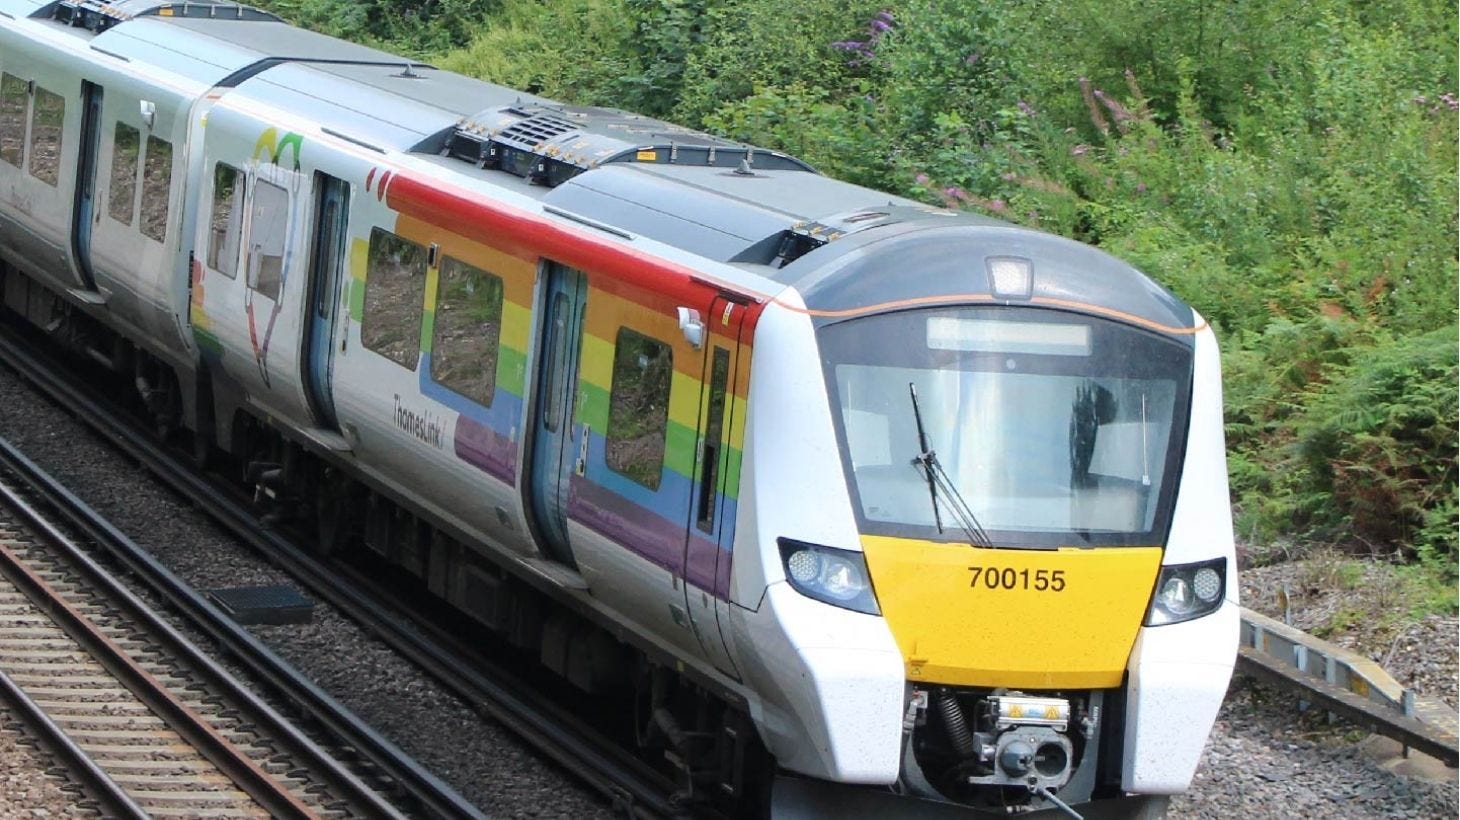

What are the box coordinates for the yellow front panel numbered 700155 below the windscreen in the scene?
[861,535,1161,689]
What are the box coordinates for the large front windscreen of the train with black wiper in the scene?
[819,306,1191,547]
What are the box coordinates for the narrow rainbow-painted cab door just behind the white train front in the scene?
[682,298,740,674]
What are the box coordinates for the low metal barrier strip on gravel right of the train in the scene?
[1237,607,1460,767]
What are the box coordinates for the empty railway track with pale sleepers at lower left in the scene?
[0,452,394,817]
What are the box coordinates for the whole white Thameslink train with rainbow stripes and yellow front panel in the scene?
[0,0,1238,817]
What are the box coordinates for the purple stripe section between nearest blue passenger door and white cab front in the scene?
[568,476,730,598]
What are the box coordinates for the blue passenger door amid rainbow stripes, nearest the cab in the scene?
[527,263,588,566]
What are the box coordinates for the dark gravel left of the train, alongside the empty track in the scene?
[0,368,613,817]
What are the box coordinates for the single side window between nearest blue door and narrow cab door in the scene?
[604,327,675,490]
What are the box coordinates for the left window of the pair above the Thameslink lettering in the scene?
[361,228,426,369]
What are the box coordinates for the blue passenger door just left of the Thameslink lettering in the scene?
[301,172,350,429]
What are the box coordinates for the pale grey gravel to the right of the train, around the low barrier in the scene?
[1171,554,1460,820]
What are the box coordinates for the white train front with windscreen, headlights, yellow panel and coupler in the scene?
[740,284,1238,817]
